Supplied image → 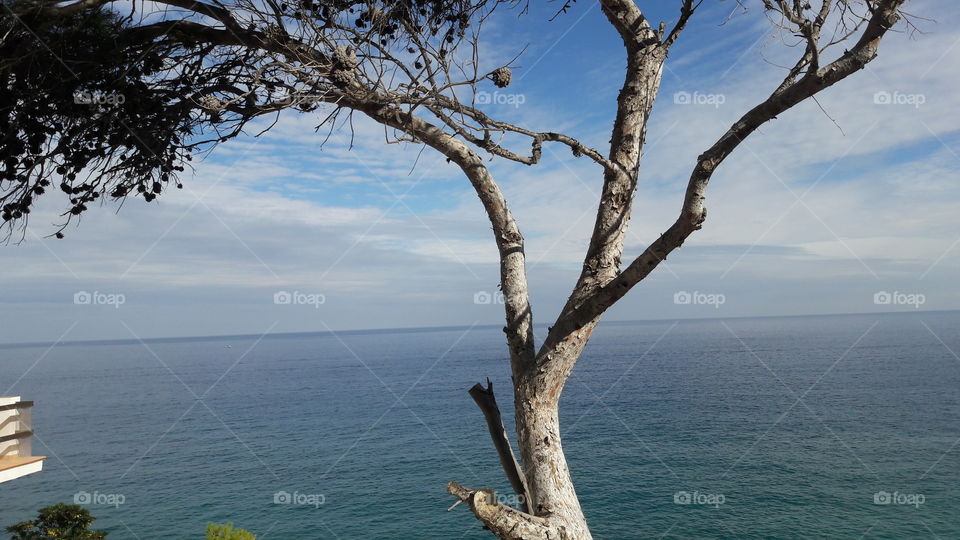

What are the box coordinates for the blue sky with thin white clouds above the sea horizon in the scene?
[0,0,960,343]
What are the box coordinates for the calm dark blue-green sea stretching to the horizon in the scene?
[0,313,960,540]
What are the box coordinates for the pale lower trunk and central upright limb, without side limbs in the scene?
[498,12,666,539]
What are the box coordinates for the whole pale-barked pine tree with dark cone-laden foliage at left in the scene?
[0,0,909,539]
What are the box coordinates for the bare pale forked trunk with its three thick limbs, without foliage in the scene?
[436,0,904,540]
